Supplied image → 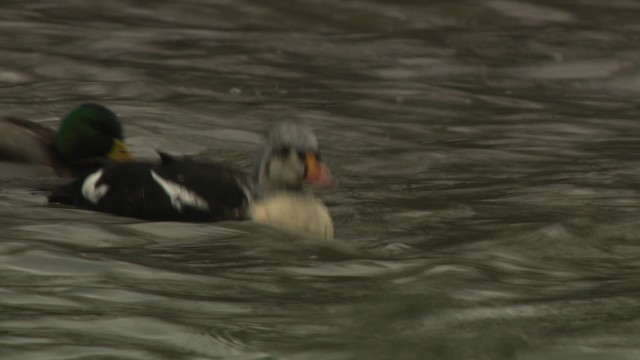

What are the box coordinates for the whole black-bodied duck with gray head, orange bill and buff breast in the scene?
[48,120,334,240]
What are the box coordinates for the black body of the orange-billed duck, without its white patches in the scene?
[49,154,250,221]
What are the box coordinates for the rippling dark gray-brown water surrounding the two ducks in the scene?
[0,0,640,360]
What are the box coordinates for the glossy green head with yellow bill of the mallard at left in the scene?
[53,104,133,163]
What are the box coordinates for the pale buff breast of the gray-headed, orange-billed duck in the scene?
[250,193,333,240]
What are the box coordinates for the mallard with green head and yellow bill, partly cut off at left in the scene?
[0,103,133,177]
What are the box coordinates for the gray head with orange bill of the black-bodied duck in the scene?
[257,121,330,190]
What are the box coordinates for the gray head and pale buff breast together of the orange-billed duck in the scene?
[248,121,337,240]
